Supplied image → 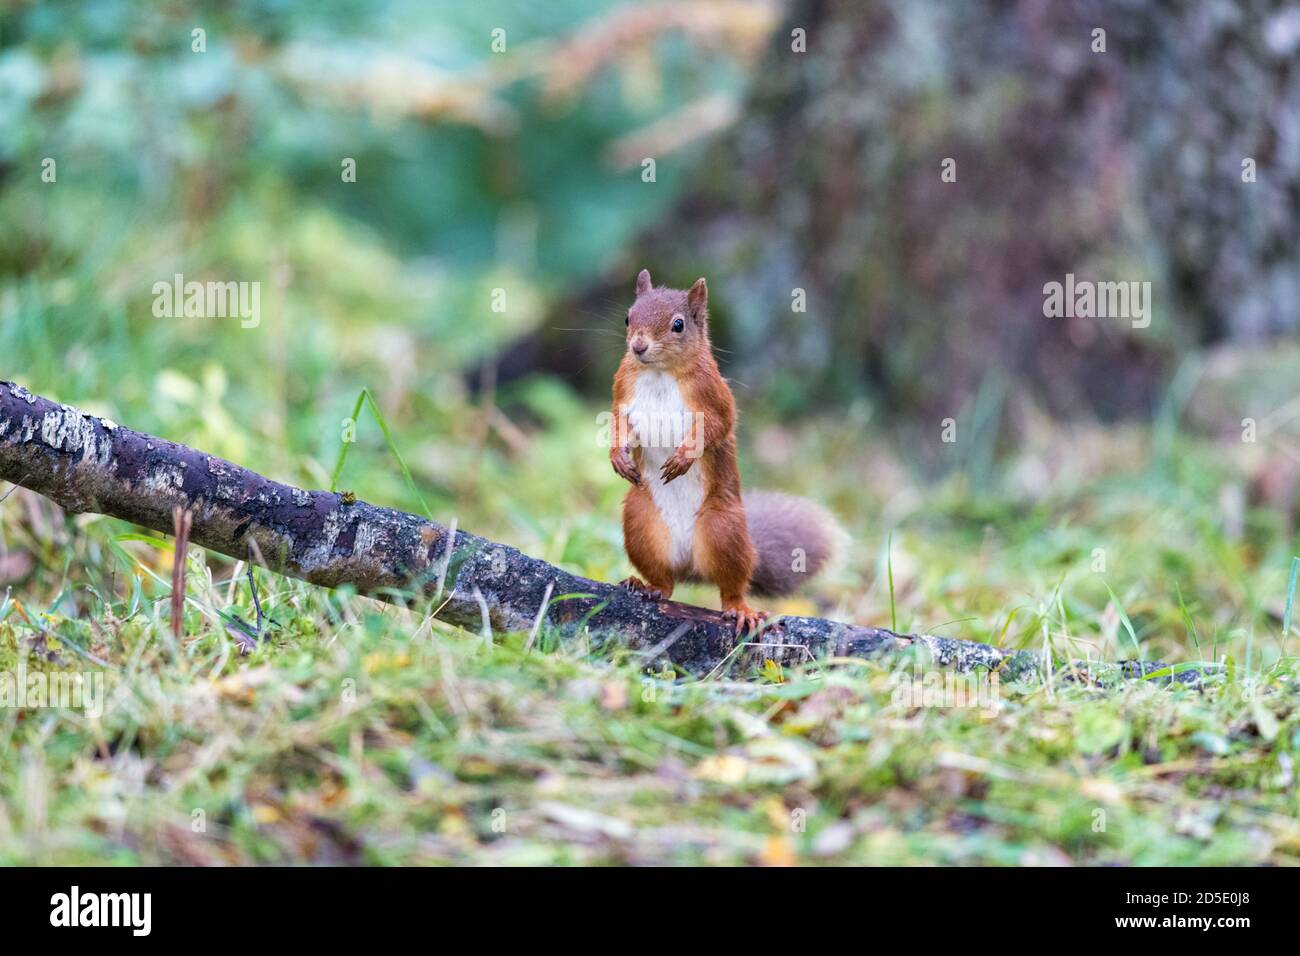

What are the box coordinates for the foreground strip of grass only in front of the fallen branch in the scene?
[0,574,1300,865]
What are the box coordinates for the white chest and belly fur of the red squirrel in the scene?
[628,372,705,571]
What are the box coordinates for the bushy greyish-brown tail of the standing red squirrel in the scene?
[744,492,845,597]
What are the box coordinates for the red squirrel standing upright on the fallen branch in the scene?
[610,269,841,635]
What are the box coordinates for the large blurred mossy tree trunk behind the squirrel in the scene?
[548,0,1300,426]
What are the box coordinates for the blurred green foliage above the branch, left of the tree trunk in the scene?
[0,0,759,505]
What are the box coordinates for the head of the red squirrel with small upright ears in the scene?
[627,269,710,371]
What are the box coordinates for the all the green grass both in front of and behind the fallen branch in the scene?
[0,400,1300,865]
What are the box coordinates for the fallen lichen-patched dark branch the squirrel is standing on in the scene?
[0,382,1196,679]
